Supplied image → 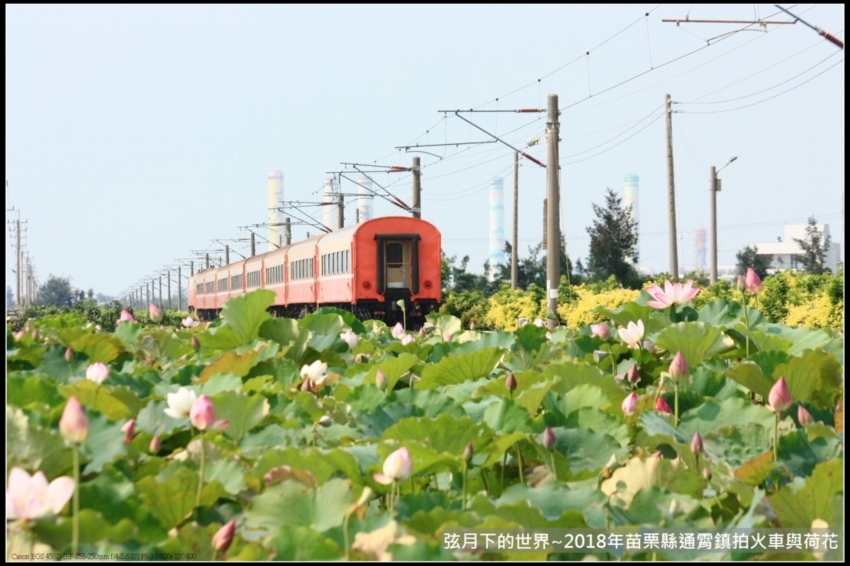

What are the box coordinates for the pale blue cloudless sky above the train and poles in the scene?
[6,4,845,296]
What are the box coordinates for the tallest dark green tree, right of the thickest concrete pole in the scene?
[587,188,640,287]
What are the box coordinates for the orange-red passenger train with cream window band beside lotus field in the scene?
[188,216,442,330]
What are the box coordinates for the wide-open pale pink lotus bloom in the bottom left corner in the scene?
[6,467,75,521]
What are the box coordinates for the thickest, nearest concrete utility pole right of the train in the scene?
[546,94,561,330]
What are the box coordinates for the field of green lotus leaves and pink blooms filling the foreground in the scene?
[6,279,844,561]
